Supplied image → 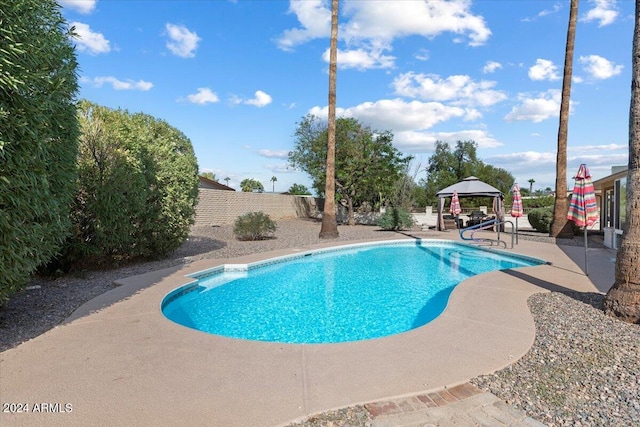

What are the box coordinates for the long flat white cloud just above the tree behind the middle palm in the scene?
[309,99,467,132]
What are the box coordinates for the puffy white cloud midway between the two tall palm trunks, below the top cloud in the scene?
[392,72,507,107]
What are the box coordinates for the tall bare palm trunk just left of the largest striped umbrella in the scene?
[549,0,578,238]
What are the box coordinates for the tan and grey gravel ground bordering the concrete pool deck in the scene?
[0,220,640,426]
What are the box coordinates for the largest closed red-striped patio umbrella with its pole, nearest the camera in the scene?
[567,163,598,276]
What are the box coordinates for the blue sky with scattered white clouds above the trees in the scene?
[59,0,634,195]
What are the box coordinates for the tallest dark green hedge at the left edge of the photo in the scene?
[0,0,78,304]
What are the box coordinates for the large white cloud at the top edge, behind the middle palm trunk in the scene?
[276,0,491,70]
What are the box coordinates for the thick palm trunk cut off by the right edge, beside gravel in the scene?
[603,0,640,324]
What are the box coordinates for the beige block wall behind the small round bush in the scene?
[195,188,320,226]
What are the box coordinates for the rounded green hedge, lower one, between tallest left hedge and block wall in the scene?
[57,101,198,268]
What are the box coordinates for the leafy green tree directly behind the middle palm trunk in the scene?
[289,115,411,224]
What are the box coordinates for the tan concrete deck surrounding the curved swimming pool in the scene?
[0,233,615,426]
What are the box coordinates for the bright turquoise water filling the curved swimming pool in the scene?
[162,241,543,343]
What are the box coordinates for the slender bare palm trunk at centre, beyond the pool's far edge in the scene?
[320,0,339,239]
